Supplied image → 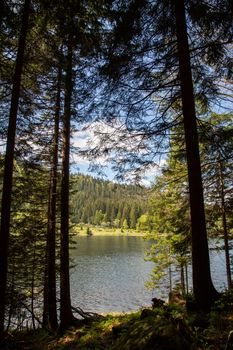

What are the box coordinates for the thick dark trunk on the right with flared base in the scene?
[174,0,218,308]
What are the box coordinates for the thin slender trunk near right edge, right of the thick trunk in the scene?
[219,157,232,289]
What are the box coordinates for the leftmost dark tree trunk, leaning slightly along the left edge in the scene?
[0,0,30,337]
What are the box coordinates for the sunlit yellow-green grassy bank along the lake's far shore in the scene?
[71,225,146,237]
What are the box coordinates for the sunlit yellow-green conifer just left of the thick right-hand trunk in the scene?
[148,145,191,293]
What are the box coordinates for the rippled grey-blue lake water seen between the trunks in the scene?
[71,236,229,313]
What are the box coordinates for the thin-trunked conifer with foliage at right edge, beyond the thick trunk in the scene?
[200,113,233,288]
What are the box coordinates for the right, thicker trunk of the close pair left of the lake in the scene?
[60,41,74,330]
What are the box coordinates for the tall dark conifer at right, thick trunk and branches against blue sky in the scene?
[87,0,229,308]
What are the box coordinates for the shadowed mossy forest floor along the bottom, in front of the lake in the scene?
[1,293,233,350]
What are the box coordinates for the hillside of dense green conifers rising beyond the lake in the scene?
[71,174,148,228]
